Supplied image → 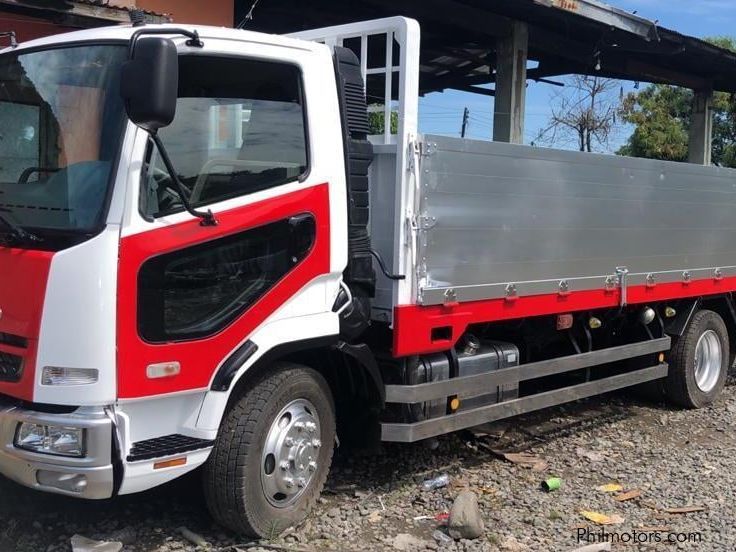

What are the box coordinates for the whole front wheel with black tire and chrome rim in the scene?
[204,363,335,538]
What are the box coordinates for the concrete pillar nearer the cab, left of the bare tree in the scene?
[493,21,529,144]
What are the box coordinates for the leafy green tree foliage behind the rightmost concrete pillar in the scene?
[617,37,736,167]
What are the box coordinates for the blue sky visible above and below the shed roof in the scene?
[419,0,736,152]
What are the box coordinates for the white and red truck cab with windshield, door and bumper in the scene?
[0,22,347,512]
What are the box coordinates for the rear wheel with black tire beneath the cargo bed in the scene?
[664,310,730,408]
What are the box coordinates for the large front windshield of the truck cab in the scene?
[0,45,127,242]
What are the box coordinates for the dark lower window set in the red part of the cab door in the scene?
[138,214,316,343]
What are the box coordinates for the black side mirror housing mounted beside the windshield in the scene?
[120,36,179,134]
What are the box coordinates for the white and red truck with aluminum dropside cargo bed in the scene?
[0,18,736,535]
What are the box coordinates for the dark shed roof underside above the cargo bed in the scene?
[247,0,736,93]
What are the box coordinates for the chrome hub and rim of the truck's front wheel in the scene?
[261,399,322,508]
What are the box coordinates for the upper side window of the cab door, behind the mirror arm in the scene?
[140,56,308,217]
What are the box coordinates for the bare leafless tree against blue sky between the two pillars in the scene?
[537,75,620,152]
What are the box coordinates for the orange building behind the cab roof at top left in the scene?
[0,0,235,47]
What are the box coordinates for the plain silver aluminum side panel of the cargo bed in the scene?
[416,136,736,304]
